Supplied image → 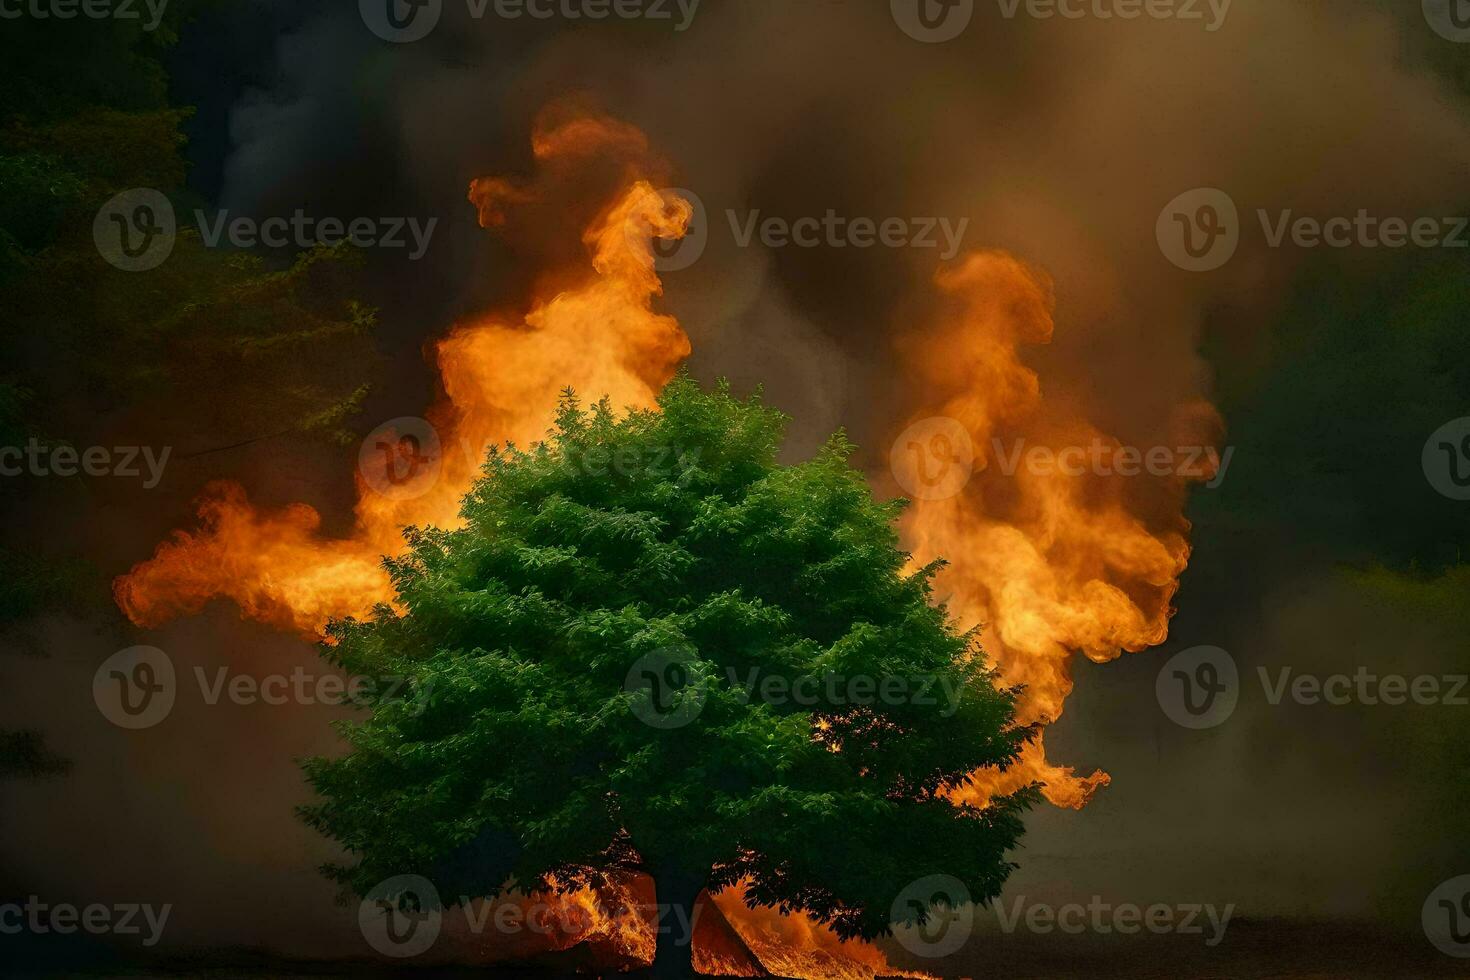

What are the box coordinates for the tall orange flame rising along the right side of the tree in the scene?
[892,251,1214,808]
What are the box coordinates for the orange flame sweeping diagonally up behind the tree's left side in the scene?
[113,107,692,638]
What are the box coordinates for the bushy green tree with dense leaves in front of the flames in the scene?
[303,378,1033,976]
